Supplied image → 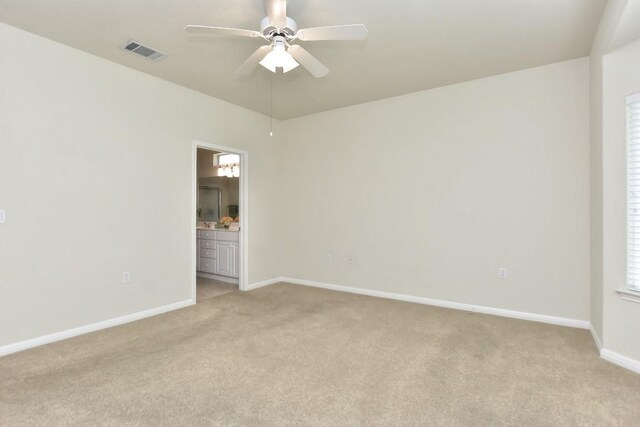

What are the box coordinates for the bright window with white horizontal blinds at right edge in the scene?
[627,93,640,291]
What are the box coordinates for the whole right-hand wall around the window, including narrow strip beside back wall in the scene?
[590,0,640,363]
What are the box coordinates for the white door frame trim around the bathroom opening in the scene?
[190,140,249,303]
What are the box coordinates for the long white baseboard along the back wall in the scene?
[281,277,590,329]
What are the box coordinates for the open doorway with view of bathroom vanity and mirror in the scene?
[193,142,247,302]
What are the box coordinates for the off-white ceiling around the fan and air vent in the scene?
[0,0,606,119]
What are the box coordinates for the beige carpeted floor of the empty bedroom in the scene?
[0,284,640,426]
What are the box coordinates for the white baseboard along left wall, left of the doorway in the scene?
[0,299,195,356]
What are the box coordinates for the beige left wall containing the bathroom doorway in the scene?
[0,24,278,346]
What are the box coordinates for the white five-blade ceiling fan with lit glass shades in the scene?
[184,0,367,78]
